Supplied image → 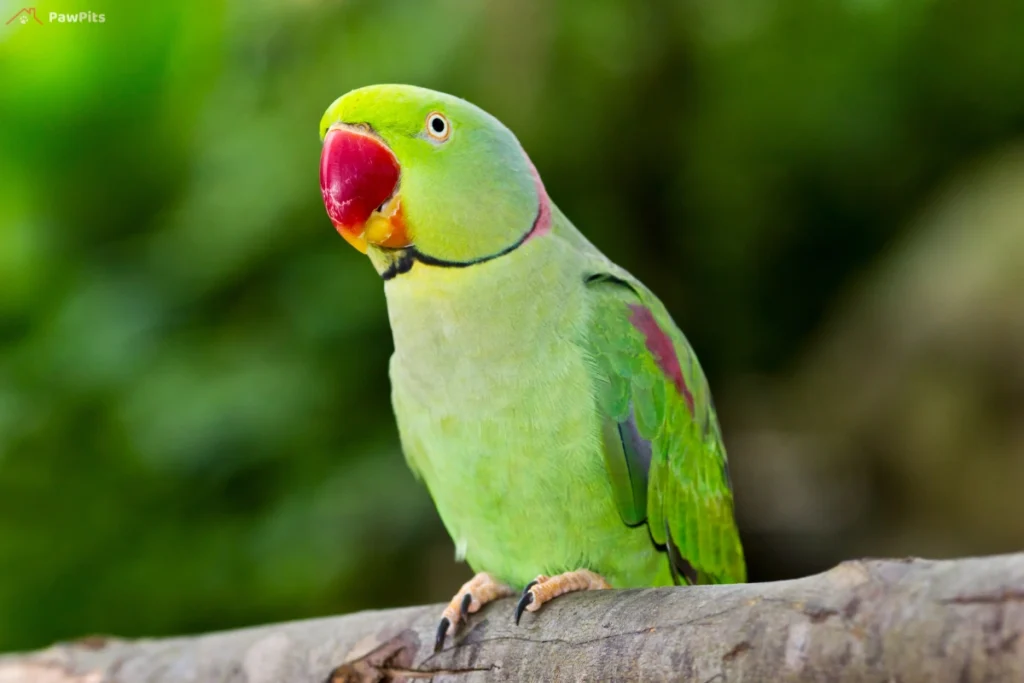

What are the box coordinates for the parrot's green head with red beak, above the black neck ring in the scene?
[319,85,551,280]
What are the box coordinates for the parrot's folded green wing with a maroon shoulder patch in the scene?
[587,270,746,584]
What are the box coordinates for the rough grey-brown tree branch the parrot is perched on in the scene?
[0,553,1024,683]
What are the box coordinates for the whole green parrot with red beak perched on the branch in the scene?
[319,85,745,649]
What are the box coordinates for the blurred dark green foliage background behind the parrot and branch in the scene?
[0,0,1024,650]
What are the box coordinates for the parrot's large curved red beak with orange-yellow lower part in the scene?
[321,127,409,254]
